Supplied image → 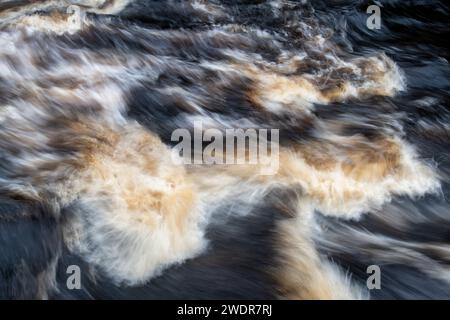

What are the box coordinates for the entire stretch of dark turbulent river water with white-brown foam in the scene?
[0,0,450,299]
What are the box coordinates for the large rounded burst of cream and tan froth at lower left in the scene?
[64,125,206,285]
